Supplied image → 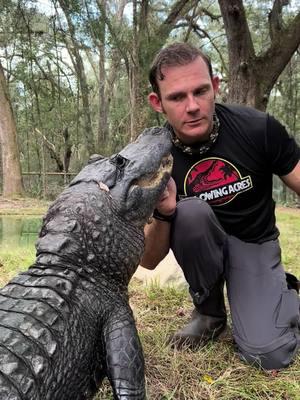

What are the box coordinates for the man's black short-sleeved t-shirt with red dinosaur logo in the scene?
[172,104,300,243]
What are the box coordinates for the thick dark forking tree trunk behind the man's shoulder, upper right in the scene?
[219,0,300,111]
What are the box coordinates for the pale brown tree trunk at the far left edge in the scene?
[0,62,24,197]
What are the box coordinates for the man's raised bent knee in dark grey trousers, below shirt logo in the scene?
[170,197,227,293]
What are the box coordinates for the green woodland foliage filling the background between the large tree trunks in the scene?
[0,0,300,202]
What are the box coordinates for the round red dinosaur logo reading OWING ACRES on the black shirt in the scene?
[184,158,253,206]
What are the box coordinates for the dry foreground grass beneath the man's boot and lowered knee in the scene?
[125,281,300,400]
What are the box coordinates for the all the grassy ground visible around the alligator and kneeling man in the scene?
[0,209,300,400]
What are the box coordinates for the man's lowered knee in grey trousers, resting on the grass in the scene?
[237,332,300,370]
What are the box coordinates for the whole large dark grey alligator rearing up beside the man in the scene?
[0,127,172,400]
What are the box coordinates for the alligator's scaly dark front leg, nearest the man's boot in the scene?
[104,306,146,400]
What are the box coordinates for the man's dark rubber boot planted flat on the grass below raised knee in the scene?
[169,279,227,349]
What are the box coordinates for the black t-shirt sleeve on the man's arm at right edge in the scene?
[266,115,300,176]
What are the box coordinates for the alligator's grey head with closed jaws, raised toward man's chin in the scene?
[71,127,172,226]
